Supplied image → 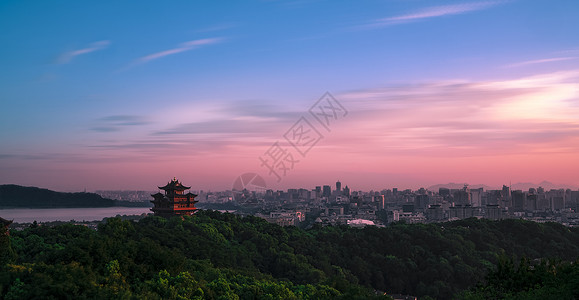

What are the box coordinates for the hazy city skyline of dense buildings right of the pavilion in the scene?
[204,181,579,227]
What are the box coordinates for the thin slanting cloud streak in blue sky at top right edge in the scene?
[359,1,501,29]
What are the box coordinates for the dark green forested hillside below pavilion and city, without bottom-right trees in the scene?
[0,211,579,299]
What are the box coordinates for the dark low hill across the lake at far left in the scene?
[0,184,115,208]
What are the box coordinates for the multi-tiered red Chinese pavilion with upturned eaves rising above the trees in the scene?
[151,178,199,217]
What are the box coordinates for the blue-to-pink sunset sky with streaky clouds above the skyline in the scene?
[0,0,579,191]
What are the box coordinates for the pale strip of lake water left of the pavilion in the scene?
[0,207,151,223]
